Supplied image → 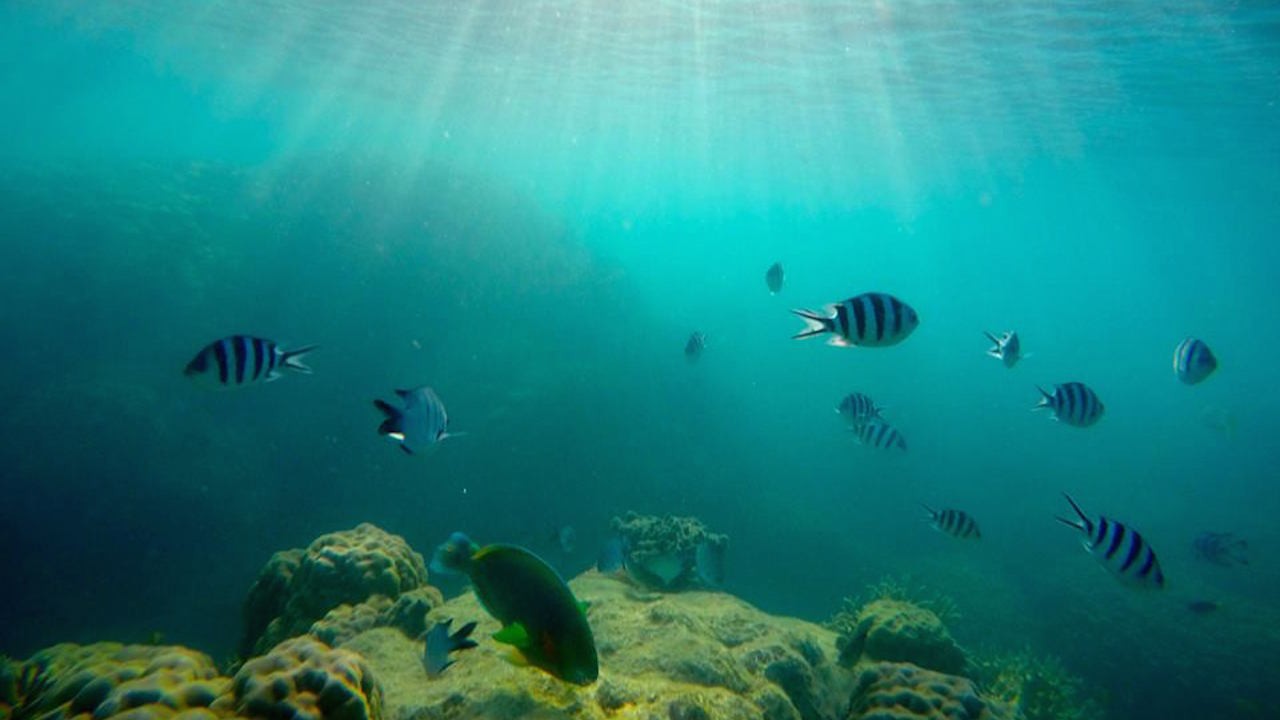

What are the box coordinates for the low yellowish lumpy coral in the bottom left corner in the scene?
[14,643,228,720]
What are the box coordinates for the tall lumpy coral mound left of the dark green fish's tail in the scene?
[241,523,426,656]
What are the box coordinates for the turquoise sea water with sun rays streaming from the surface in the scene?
[0,1,1280,717]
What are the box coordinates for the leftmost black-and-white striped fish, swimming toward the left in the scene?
[183,334,316,388]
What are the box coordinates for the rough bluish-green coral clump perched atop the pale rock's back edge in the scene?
[612,512,728,591]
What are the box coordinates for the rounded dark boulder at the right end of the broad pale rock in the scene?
[837,598,965,675]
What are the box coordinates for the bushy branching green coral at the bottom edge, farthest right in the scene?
[970,648,1106,720]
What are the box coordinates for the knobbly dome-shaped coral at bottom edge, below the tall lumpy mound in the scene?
[219,638,383,720]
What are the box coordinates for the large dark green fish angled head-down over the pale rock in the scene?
[431,533,600,685]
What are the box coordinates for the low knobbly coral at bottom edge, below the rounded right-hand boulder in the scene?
[845,662,1015,720]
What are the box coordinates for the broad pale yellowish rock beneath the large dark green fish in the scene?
[342,571,855,720]
